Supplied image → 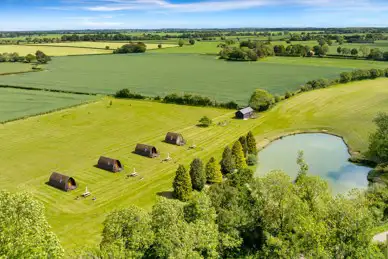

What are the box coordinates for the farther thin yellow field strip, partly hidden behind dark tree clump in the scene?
[29,41,177,50]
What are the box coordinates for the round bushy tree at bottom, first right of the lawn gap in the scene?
[100,205,154,258]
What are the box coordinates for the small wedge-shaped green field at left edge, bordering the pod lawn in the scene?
[0,88,96,123]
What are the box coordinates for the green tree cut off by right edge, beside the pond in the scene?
[368,113,388,163]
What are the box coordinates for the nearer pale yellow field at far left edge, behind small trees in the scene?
[0,45,112,56]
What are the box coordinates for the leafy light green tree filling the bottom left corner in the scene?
[0,191,64,258]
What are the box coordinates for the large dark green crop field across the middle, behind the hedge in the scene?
[0,53,358,105]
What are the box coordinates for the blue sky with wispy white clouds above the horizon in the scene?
[0,0,388,31]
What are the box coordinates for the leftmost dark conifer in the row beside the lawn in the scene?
[173,165,193,201]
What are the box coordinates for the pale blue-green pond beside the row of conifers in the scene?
[256,133,371,194]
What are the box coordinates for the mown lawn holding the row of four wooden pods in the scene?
[0,99,256,251]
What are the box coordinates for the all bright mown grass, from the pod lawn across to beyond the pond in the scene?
[0,79,388,251]
